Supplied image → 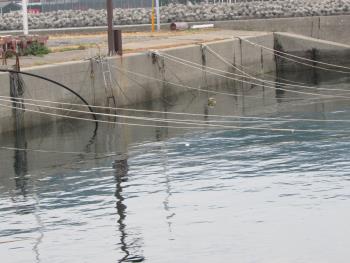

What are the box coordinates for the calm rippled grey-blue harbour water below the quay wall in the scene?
[0,69,350,263]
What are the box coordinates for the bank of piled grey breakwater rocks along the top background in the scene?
[0,0,350,30]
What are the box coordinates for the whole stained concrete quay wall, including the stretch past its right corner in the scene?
[0,30,349,135]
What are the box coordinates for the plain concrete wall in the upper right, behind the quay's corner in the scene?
[215,15,350,44]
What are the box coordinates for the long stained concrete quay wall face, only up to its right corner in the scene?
[0,33,274,135]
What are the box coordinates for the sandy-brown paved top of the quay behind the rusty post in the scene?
[2,29,264,67]
